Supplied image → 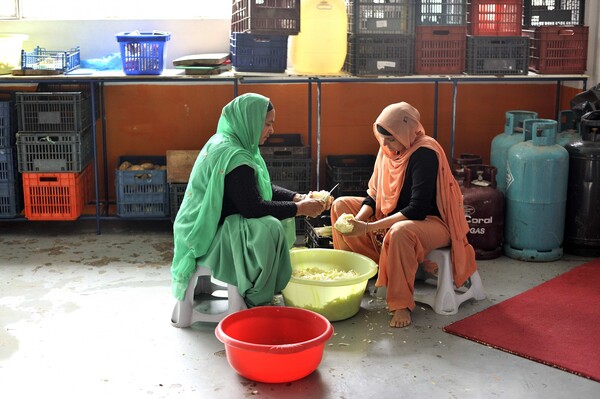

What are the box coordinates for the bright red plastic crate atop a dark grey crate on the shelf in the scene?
[467,0,523,36]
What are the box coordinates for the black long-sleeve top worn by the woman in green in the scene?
[219,165,298,224]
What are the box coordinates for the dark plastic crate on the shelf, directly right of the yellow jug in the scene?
[344,35,414,76]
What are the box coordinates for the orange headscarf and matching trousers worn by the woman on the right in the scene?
[331,102,477,311]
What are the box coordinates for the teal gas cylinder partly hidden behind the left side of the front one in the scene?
[490,111,537,194]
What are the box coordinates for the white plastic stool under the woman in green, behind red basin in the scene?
[171,266,247,327]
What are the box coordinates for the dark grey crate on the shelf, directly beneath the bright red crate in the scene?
[465,35,529,75]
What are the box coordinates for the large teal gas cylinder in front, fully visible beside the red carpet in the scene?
[504,119,569,262]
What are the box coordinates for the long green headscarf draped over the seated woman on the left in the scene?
[171,93,273,300]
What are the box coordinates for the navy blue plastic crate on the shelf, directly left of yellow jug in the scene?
[230,32,288,72]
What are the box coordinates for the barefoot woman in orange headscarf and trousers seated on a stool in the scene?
[331,102,477,327]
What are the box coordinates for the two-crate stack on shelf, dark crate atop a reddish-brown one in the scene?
[415,0,467,75]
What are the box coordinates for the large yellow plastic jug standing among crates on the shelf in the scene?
[288,0,348,75]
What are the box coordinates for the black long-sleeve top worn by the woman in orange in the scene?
[363,147,440,220]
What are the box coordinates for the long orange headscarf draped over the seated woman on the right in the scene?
[367,102,477,286]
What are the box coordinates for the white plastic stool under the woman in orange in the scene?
[414,248,486,315]
